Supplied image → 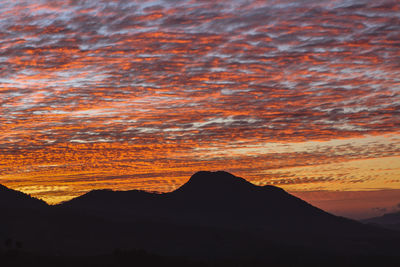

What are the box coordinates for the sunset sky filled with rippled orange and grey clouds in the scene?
[0,0,400,218]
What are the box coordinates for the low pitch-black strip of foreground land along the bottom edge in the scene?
[1,250,399,267]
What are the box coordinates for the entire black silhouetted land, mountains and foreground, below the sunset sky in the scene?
[0,172,400,266]
